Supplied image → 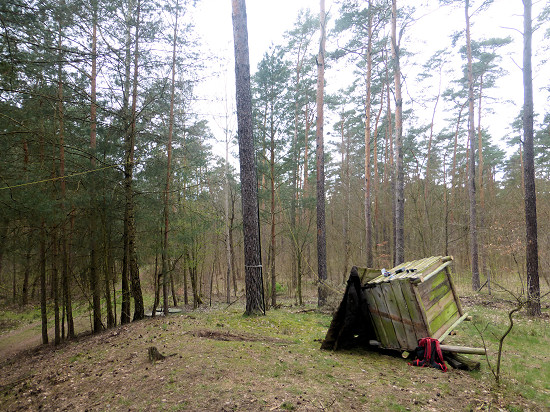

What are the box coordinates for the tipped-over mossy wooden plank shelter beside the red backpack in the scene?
[321,256,485,354]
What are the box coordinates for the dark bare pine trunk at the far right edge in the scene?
[523,0,541,316]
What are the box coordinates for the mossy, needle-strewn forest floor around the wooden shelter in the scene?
[0,295,550,411]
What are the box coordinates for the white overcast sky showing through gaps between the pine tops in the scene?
[194,0,550,161]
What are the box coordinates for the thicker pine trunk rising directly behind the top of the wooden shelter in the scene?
[392,0,405,265]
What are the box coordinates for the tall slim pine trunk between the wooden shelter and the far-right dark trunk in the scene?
[465,0,480,291]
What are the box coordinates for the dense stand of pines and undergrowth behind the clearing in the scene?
[0,0,550,343]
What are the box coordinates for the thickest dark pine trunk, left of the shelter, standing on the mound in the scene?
[232,0,265,315]
